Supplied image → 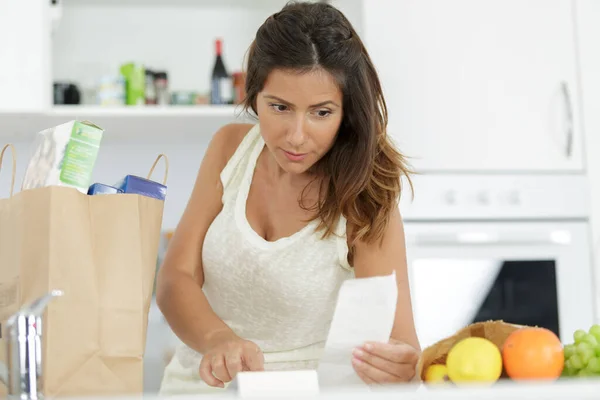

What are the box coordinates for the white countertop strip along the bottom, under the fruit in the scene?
[50,378,600,400]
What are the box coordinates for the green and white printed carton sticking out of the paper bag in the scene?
[23,121,104,193]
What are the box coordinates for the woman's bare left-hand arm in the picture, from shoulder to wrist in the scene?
[156,124,248,354]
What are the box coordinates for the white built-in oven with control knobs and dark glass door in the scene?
[400,174,597,347]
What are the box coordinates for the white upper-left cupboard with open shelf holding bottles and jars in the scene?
[0,0,294,143]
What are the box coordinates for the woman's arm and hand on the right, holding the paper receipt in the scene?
[354,208,421,383]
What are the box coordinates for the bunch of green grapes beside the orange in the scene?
[563,325,600,377]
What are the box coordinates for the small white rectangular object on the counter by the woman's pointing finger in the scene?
[236,370,319,398]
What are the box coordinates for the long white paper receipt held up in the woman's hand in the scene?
[317,272,398,388]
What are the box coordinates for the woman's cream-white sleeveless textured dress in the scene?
[161,124,354,394]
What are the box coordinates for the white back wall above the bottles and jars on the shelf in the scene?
[52,0,292,99]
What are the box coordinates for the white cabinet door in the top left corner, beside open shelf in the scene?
[0,0,52,111]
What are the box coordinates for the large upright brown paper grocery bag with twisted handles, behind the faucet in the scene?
[0,148,168,396]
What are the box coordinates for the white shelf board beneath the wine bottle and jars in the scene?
[0,105,252,144]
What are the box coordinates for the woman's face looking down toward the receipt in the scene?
[256,69,343,174]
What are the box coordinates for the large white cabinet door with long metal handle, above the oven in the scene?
[363,0,583,171]
